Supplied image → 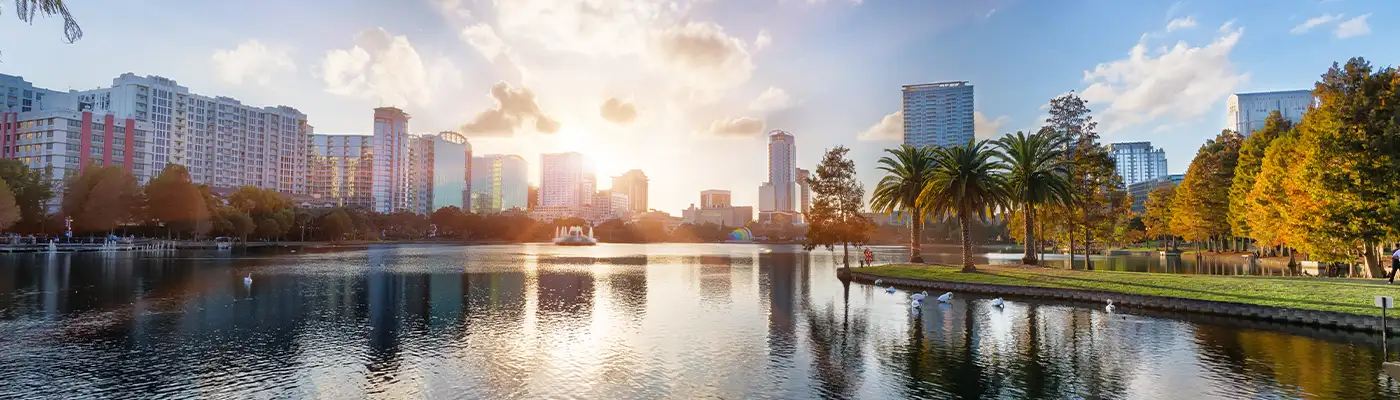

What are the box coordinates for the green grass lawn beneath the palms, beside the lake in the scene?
[853,266,1400,316]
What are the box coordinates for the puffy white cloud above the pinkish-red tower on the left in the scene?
[319,28,462,105]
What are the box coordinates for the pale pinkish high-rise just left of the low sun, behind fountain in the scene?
[539,152,598,211]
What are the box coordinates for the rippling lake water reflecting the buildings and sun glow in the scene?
[0,245,1400,399]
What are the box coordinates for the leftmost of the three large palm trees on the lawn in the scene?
[871,144,934,263]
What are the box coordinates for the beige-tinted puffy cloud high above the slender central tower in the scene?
[651,22,753,102]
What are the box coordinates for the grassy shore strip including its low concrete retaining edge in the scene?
[837,266,1400,333]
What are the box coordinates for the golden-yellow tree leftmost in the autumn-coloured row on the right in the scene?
[1172,129,1245,250]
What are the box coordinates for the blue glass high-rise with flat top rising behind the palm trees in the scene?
[904,81,976,147]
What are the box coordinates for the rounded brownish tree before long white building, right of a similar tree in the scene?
[146,164,209,235]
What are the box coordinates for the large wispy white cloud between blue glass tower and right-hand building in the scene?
[1079,28,1249,133]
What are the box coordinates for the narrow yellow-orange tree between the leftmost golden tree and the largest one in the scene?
[1229,110,1294,239]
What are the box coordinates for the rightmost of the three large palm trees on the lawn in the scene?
[995,129,1071,266]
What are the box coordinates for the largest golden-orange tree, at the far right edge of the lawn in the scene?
[1298,57,1400,277]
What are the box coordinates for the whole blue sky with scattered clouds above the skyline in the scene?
[0,0,1400,214]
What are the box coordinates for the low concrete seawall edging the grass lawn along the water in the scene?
[837,270,1400,333]
